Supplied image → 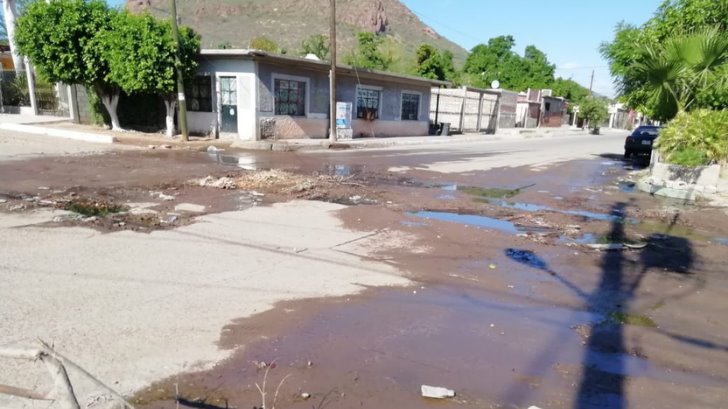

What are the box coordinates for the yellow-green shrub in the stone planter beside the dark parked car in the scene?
[657,109,728,166]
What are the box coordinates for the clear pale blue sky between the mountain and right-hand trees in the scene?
[107,0,661,96]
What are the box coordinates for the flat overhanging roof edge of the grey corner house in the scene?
[200,49,450,87]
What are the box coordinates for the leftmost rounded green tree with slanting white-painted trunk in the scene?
[15,0,121,130]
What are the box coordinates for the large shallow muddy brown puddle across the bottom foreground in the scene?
[192,286,719,409]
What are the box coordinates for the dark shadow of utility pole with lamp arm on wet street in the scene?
[505,202,700,409]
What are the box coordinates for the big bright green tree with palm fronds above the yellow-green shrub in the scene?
[600,0,728,119]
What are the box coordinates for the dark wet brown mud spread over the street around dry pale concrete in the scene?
[0,145,728,409]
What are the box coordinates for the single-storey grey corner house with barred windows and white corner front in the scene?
[186,49,448,140]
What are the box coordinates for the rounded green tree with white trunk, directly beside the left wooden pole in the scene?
[100,12,200,137]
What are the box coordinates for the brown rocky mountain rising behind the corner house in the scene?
[127,0,466,62]
